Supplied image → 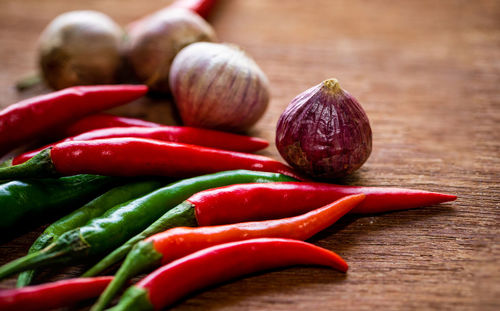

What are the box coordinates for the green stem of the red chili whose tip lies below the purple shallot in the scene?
[0,148,58,180]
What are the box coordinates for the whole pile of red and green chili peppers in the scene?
[0,0,456,311]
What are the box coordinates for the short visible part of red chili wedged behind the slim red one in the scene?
[58,113,162,137]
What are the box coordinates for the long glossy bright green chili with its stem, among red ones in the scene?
[0,170,293,279]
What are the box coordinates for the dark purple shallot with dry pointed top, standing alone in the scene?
[276,79,372,178]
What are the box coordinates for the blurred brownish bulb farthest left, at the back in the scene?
[38,11,123,89]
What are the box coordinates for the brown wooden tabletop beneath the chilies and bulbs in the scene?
[0,0,500,310]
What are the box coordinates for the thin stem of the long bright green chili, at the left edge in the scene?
[0,232,89,280]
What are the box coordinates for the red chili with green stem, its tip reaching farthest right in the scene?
[83,182,456,276]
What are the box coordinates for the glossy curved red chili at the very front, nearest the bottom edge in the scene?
[110,238,348,311]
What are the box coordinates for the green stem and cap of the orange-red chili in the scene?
[90,241,163,311]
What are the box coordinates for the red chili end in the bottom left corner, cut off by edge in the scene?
[0,276,113,311]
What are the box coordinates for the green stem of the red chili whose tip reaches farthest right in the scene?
[82,202,197,277]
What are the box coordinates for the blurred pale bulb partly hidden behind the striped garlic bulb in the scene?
[126,8,215,93]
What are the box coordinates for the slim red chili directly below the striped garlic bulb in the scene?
[12,126,269,165]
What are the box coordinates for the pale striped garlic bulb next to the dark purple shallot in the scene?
[170,42,270,132]
